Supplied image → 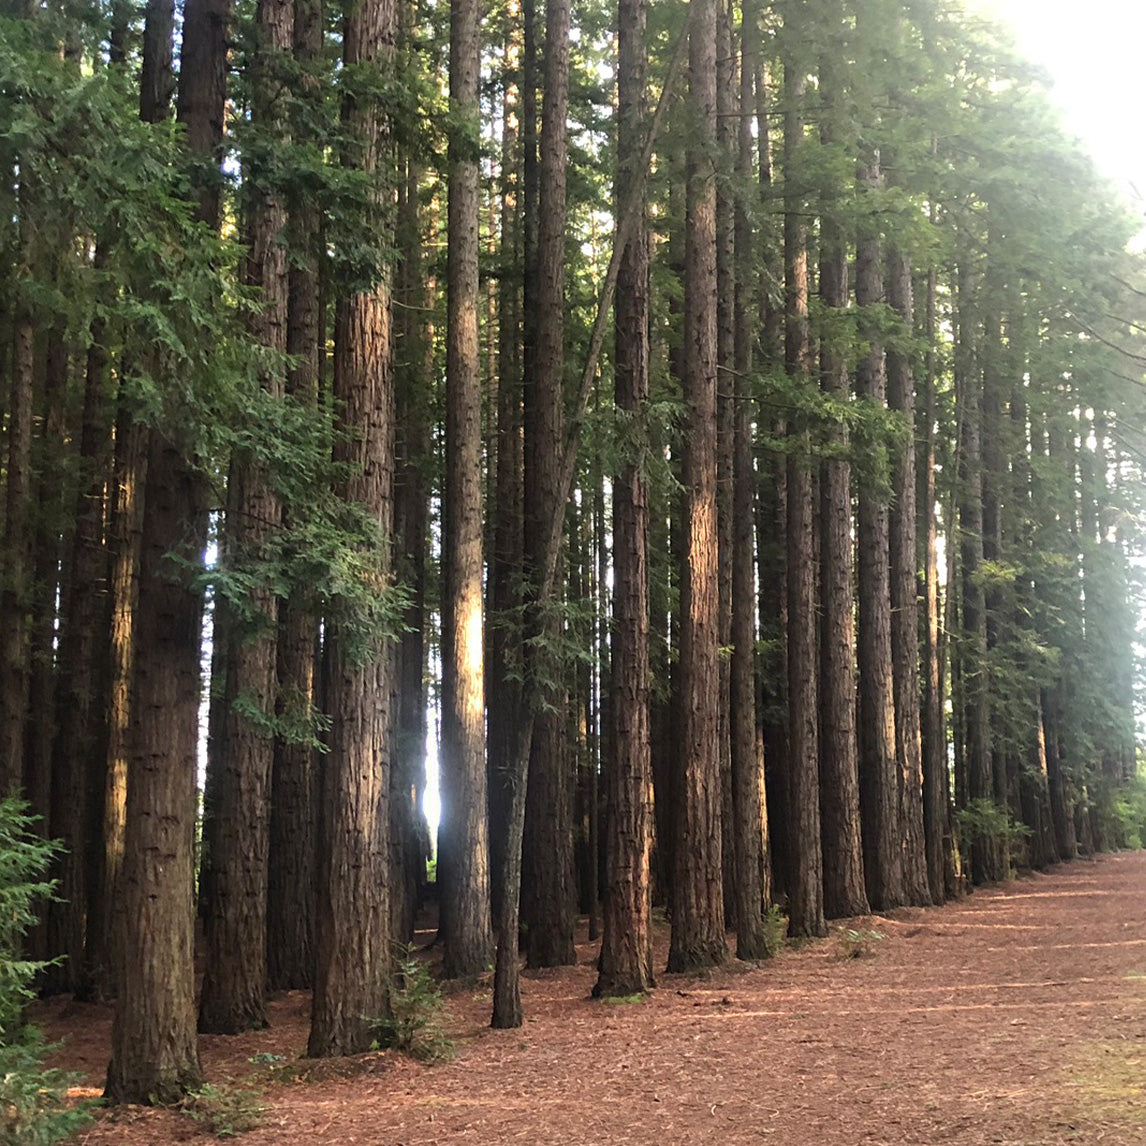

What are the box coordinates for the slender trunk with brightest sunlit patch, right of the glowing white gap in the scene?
[438,0,493,979]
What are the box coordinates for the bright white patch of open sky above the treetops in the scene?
[978,0,1146,221]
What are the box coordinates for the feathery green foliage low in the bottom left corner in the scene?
[0,798,88,1146]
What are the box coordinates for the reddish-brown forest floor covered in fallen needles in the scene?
[38,851,1146,1146]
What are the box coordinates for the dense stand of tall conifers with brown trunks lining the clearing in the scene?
[0,0,1146,1118]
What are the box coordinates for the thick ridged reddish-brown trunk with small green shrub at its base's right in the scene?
[307,0,395,1058]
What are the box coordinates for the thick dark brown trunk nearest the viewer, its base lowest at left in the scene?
[107,0,226,1102]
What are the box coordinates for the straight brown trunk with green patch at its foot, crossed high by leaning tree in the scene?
[592,0,653,997]
